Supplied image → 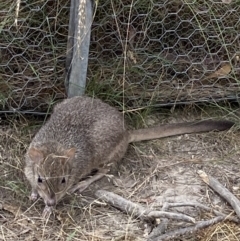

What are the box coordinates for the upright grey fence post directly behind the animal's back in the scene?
[65,0,93,98]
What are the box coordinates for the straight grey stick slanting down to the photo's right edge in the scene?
[197,170,240,218]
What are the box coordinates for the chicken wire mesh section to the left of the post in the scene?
[0,0,70,112]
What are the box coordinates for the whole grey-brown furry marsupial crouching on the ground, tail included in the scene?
[25,97,234,209]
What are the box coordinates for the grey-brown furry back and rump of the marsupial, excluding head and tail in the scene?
[31,97,128,173]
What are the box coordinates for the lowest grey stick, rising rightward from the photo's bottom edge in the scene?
[147,216,225,241]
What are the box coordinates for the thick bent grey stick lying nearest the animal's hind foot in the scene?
[95,190,195,223]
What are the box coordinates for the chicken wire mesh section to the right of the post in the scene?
[88,0,240,107]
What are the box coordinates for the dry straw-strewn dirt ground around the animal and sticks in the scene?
[0,110,240,241]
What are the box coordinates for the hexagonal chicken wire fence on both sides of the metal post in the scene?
[0,0,240,112]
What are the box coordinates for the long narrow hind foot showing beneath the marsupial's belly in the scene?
[69,169,109,193]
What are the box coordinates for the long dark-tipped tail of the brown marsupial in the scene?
[129,120,235,143]
